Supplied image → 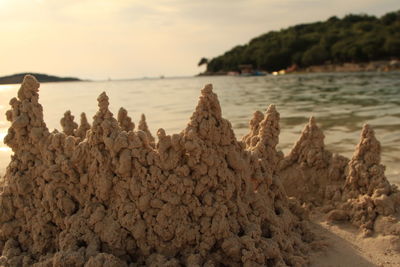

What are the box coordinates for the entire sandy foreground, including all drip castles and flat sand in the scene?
[0,76,400,266]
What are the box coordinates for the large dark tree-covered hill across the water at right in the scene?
[205,11,400,74]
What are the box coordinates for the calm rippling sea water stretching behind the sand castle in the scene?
[0,72,400,183]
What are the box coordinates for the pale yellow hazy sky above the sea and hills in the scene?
[0,0,400,80]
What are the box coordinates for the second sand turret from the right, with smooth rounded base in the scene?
[279,117,348,209]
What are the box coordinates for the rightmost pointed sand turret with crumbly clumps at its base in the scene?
[328,124,400,237]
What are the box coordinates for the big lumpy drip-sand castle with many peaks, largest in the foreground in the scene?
[0,76,314,266]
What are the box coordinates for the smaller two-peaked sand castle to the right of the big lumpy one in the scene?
[279,118,400,237]
